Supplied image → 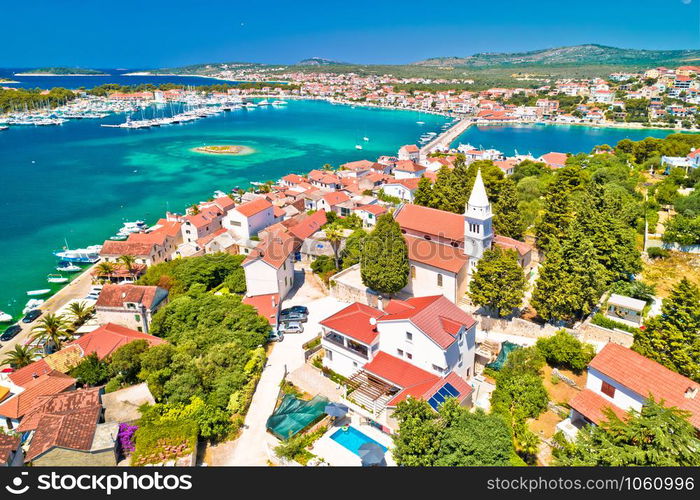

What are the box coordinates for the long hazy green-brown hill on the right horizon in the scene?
[413,44,700,69]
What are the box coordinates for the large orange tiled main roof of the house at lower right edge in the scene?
[588,342,700,428]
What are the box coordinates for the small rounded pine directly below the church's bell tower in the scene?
[469,247,526,316]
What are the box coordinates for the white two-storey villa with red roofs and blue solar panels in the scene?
[320,295,476,430]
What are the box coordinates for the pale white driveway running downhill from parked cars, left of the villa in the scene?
[221,274,348,465]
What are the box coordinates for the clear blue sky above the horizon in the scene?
[0,0,700,68]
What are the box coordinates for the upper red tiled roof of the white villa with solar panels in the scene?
[378,295,476,349]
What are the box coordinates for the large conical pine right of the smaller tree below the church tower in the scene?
[531,224,603,321]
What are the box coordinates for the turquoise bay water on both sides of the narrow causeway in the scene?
[0,101,680,322]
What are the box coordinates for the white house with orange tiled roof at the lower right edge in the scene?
[564,342,700,437]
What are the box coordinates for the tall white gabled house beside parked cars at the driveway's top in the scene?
[242,231,298,300]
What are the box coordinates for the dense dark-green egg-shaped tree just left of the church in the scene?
[360,214,409,295]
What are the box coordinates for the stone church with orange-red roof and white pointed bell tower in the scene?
[394,171,533,303]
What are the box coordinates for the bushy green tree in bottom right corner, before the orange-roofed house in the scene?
[555,398,700,467]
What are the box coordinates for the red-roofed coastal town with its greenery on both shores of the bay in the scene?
[0,60,700,467]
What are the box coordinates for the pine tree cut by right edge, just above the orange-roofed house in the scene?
[632,278,700,382]
